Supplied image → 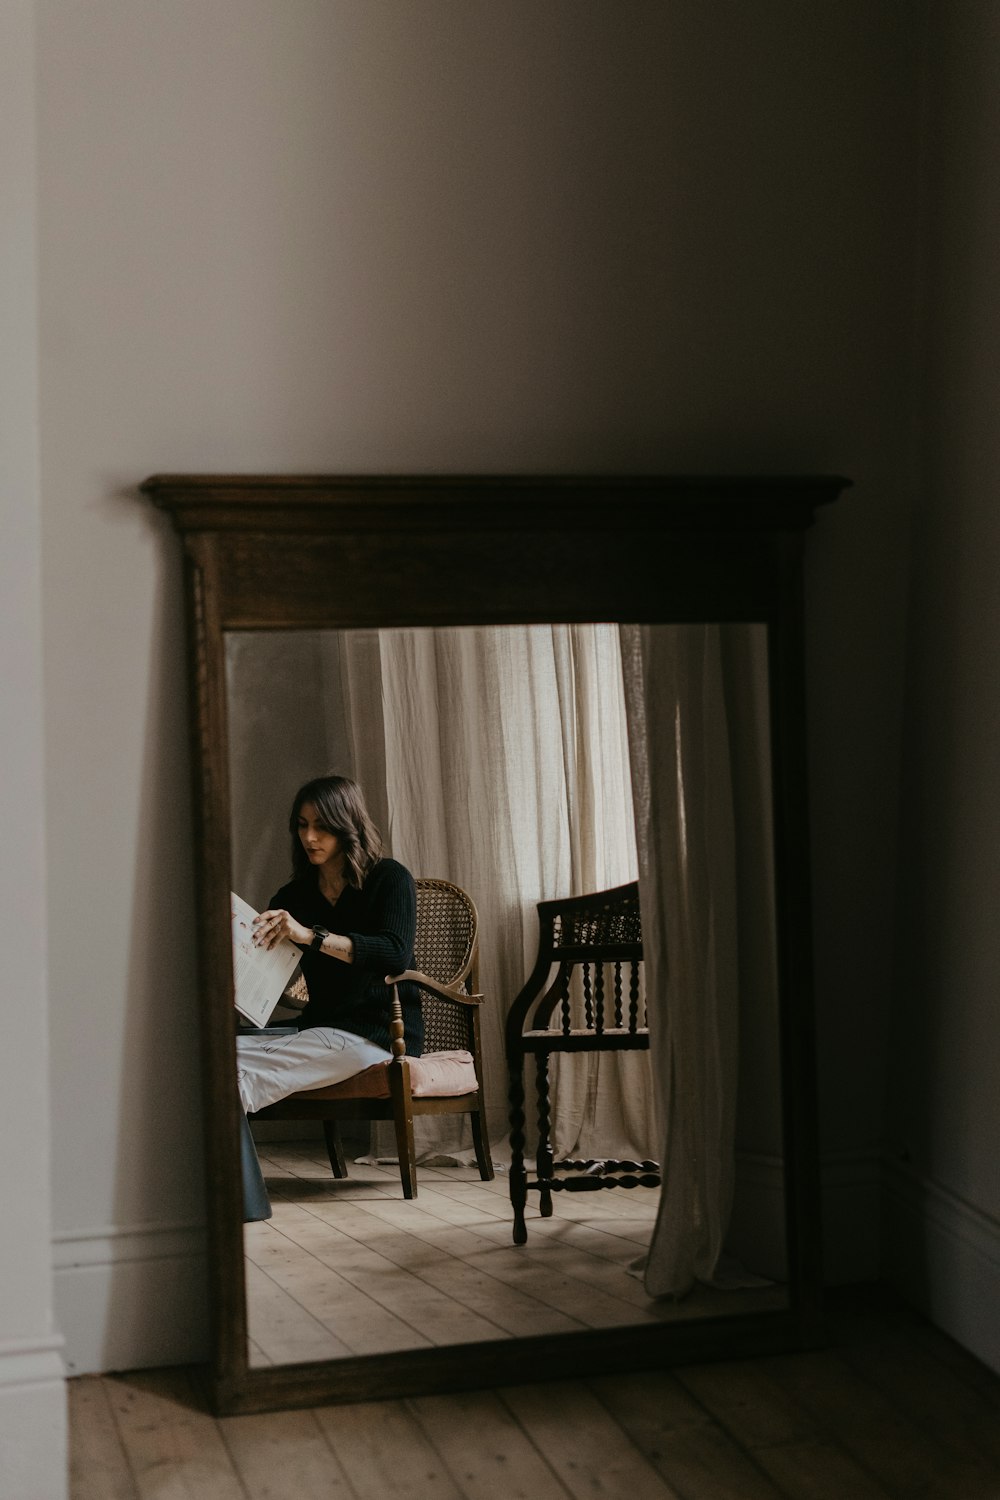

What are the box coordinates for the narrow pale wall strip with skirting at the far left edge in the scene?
[0,3,66,1500]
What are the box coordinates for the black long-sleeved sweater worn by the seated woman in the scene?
[268,860,423,1058]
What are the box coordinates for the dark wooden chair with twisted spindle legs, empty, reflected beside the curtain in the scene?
[505,881,660,1245]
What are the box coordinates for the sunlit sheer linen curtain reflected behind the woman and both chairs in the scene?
[331,626,655,1163]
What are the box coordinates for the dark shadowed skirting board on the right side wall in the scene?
[882,1161,1000,1373]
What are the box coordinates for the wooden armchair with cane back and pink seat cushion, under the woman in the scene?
[250,879,493,1199]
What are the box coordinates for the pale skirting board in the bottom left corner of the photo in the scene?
[0,1338,69,1500]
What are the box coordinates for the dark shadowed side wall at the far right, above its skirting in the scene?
[886,0,1000,1368]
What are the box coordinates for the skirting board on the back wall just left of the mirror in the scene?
[52,1224,208,1374]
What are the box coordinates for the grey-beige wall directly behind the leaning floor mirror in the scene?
[37,0,915,1370]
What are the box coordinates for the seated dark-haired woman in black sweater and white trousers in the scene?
[237,776,423,1115]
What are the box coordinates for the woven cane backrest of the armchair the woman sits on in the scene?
[414,878,480,1053]
